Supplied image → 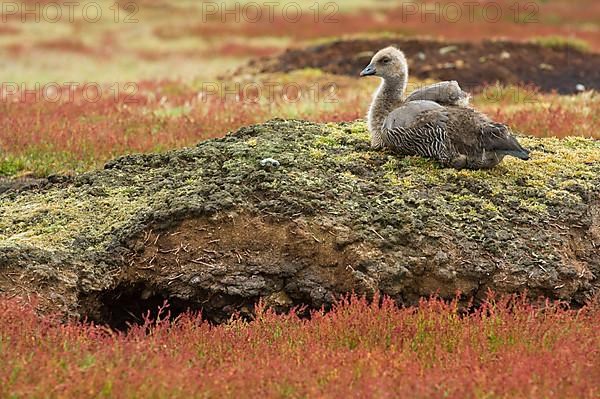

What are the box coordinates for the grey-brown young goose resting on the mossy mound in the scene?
[361,47,529,169]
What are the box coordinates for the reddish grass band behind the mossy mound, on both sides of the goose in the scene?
[0,75,600,175]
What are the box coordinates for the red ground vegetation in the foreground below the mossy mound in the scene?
[0,296,600,398]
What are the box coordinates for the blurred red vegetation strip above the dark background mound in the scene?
[190,0,600,49]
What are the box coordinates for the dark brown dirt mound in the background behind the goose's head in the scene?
[238,39,600,94]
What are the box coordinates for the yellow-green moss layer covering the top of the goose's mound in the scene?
[0,120,600,260]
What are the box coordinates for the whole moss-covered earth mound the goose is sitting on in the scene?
[0,120,600,328]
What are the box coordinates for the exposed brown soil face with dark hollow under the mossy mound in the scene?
[80,212,360,328]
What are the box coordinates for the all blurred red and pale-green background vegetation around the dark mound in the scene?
[0,0,600,177]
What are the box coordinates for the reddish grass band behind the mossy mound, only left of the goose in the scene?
[0,82,364,174]
